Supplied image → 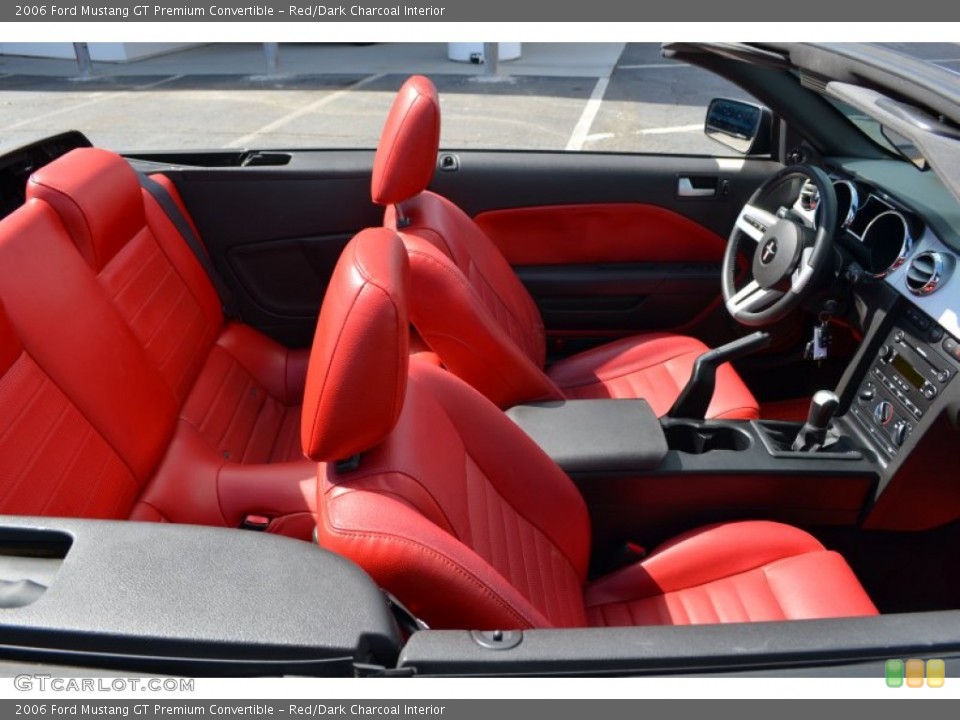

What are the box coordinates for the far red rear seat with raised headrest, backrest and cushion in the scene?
[27,148,308,463]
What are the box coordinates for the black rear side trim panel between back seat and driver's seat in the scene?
[148,150,383,347]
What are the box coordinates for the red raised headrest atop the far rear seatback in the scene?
[27,148,146,272]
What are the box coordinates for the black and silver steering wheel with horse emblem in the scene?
[721,165,837,327]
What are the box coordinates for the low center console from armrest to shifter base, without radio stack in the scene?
[507,400,878,544]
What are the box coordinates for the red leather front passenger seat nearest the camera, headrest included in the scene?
[301,228,876,629]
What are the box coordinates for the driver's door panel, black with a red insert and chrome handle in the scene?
[433,152,780,354]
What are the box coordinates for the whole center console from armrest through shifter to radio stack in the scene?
[508,298,960,552]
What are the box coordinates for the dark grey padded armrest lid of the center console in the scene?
[507,400,667,473]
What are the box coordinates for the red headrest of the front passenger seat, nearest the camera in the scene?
[300,228,410,461]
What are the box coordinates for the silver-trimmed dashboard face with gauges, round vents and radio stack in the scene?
[797,164,960,465]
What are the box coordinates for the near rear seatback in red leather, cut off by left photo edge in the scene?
[0,202,156,518]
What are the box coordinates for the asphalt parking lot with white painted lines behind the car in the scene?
[0,43,960,153]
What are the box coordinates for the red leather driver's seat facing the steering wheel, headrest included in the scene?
[371,76,759,419]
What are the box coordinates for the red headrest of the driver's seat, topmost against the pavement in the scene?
[370,75,440,205]
